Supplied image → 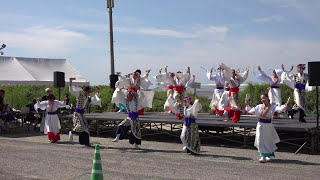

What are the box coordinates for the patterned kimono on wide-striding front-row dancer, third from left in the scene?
[116,91,141,145]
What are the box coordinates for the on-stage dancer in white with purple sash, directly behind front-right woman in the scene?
[257,66,283,118]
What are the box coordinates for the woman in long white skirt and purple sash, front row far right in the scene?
[246,93,288,163]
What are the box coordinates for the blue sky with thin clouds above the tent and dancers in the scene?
[0,0,320,84]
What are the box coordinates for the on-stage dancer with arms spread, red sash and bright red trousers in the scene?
[221,63,249,123]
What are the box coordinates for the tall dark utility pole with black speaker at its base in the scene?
[107,0,118,89]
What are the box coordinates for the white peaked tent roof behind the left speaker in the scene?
[0,56,89,86]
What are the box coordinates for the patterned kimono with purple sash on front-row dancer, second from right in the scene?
[180,100,202,154]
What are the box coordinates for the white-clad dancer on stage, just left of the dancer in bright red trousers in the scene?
[207,67,225,116]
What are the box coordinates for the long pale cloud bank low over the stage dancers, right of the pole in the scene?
[112,37,320,83]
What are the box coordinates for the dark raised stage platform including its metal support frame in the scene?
[62,112,317,152]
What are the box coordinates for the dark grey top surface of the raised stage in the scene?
[72,112,317,132]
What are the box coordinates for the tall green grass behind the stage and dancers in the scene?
[0,84,316,114]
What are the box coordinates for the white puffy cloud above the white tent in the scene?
[0,26,88,56]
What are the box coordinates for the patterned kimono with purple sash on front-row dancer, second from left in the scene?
[69,86,101,144]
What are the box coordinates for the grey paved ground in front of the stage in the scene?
[0,132,320,180]
